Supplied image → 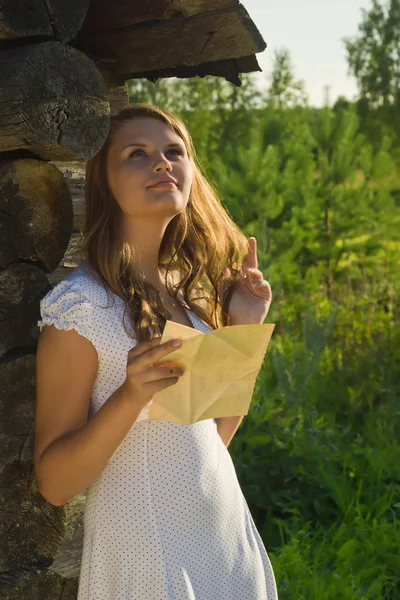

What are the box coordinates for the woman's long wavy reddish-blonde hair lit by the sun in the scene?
[77,103,248,343]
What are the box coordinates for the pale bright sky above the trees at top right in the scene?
[242,0,372,107]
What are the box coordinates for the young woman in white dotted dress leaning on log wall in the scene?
[35,104,277,600]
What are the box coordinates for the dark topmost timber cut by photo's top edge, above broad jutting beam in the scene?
[81,0,239,33]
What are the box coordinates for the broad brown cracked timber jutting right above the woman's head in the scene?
[71,4,266,79]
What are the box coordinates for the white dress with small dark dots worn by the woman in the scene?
[38,266,278,600]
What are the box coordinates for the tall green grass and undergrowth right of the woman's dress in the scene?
[229,293,400,600]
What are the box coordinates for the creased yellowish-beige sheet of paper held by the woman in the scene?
[148,321,275,425]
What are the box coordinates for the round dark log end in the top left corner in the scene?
[0,0,89,42]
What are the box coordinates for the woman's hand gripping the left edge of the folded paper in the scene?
[121,337,185,408]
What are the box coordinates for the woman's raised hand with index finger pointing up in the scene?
[220,237,272,325]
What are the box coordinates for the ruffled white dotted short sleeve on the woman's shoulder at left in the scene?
[37,281,101,356]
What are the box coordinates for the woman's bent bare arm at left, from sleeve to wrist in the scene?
[34,325,144,506]
